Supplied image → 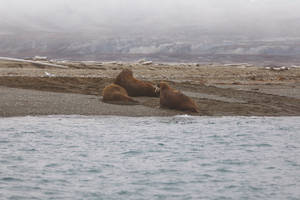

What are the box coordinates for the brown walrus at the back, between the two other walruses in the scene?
[114,69,159,97]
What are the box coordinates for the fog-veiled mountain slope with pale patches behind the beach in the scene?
[0,17,300,61]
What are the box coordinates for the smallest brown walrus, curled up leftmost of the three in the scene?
[102,84,139,105]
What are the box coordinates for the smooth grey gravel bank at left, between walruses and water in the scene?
[0,87,178,117]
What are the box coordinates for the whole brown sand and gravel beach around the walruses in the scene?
[0,61,300,117]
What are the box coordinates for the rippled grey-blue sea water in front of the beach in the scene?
[0,116,300,200]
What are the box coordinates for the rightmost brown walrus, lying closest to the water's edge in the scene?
[159,82,199,113]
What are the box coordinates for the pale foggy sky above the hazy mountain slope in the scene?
[0,0,300,35]
